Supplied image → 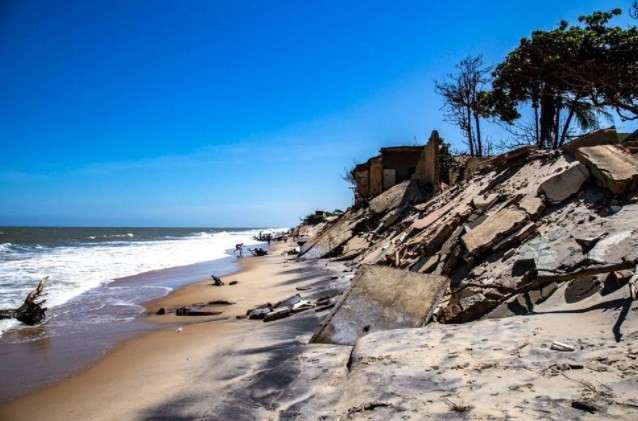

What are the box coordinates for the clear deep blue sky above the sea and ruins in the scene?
[0,0,635,226]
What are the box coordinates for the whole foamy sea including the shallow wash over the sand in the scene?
[0,227,286,402]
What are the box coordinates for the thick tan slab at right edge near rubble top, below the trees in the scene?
[576,145,638,194]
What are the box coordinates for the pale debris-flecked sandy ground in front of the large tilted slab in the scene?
[288,292,638,420]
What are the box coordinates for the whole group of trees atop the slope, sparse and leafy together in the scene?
[435,3,638,153]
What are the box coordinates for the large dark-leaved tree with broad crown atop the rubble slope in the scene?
[486,9,638,148]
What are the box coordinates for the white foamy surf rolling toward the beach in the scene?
[0,230,284,331]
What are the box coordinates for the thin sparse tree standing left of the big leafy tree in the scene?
[435,56,491,156]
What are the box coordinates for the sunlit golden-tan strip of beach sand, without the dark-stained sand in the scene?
[0,243,350,420]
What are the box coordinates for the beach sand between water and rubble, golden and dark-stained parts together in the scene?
[0,244,350,420]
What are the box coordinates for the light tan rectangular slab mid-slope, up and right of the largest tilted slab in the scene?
[461,208,527,256]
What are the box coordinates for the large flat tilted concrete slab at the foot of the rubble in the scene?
[310,266,448,345]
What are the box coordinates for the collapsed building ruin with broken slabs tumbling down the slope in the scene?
[301,128,638,324]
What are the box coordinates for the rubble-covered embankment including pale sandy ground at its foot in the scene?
[268,128,638,420]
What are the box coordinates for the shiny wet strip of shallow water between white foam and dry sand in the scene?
[0,248,241,403]
